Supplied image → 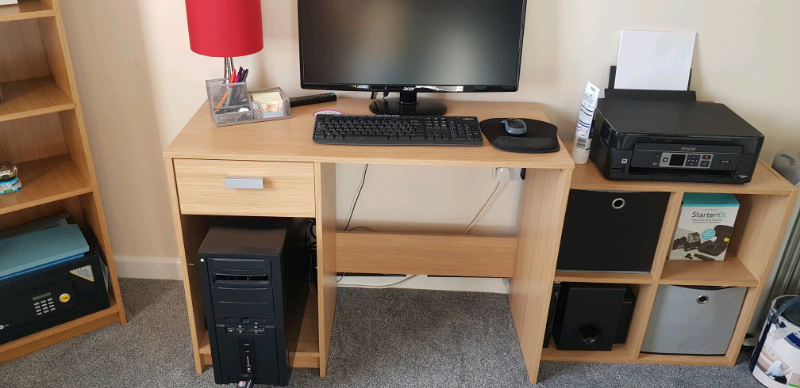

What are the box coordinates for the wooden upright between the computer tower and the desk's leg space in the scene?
[314,163,336,377]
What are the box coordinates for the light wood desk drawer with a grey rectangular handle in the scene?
[174,159,314,217]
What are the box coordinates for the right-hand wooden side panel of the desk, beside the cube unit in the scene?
[508,169,572,384]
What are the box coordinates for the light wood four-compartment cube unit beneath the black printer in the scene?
[542,143,797,366]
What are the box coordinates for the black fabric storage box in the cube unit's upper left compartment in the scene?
[556,190,670,272]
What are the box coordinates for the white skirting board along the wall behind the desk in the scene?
[114,256,508,294]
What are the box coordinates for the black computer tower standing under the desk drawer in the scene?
[198,217,314,386]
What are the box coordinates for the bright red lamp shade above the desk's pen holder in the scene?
[186,0,264,57]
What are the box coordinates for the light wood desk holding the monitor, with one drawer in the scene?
[165,98,574,382]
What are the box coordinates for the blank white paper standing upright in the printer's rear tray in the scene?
[614,31,697,90]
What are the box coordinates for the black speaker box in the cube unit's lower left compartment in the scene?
[553,283,627,350]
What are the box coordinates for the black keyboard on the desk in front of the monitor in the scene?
[314,115,483,146]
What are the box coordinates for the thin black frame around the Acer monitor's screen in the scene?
[297,0,528,93]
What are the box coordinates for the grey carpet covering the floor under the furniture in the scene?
[0,279,761,388]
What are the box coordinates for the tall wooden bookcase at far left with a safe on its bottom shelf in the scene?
[0,0,126,363]
